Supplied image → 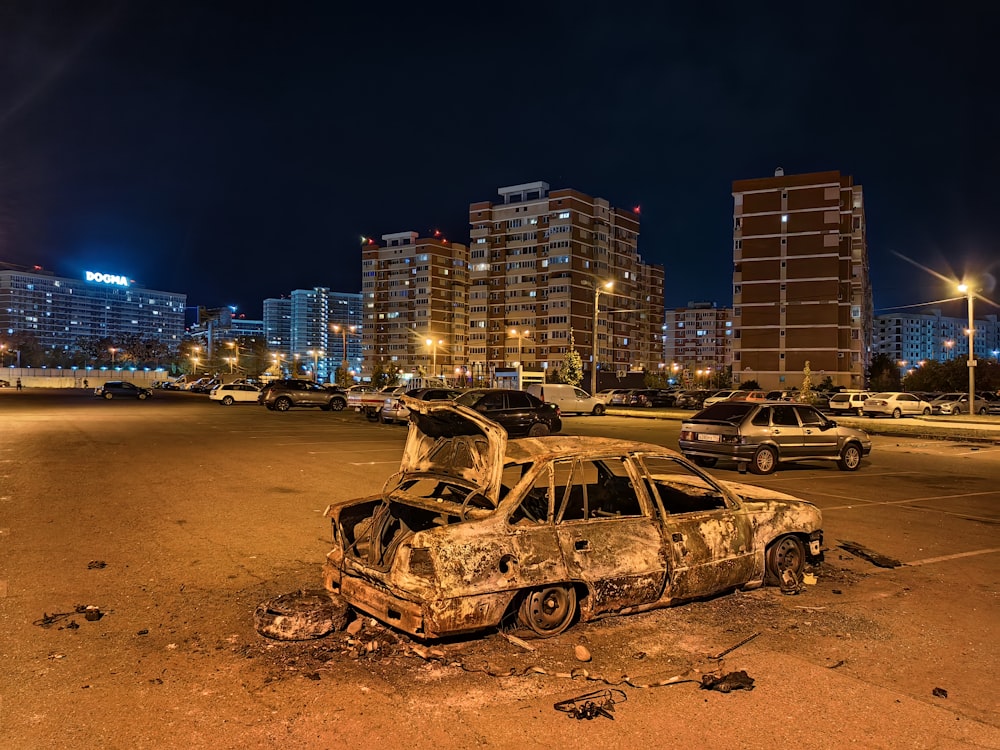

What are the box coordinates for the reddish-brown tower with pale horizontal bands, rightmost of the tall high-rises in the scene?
[733,168,873,388]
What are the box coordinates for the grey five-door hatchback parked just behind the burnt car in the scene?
[680,401,872,474]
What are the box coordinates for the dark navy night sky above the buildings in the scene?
[0,0,1000,317]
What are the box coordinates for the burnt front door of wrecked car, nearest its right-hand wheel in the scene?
[641,455,756,599]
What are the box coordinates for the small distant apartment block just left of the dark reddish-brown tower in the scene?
[663,302,733,383]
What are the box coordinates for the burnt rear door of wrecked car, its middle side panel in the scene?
[552,456,667,612]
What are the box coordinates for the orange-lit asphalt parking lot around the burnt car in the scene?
[0,392,1000,748]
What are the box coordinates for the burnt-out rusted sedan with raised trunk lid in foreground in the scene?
[324,397,822,639]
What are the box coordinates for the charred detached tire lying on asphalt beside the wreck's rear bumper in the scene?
[253,590,351,641]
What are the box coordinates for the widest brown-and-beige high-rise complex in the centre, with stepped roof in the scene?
[468,182,663,387]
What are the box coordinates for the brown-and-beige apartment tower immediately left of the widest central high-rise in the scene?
[361,232,469,378]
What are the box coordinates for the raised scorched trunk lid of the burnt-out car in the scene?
[399,396,507,503]
